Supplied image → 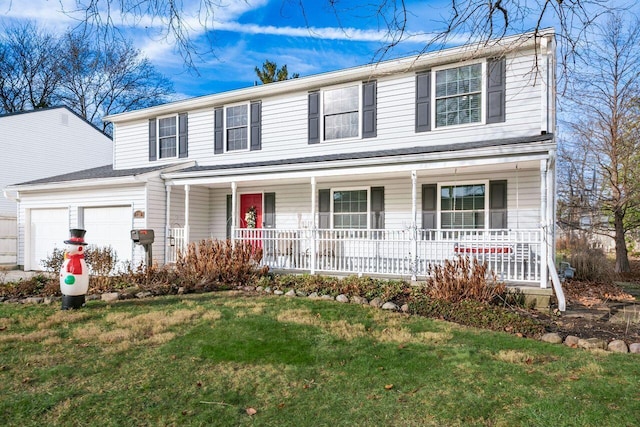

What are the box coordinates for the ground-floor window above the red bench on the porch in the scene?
[440,184,487,229]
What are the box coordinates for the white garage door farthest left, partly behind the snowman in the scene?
[25,209,69,270]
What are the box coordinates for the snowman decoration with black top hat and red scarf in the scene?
[60,228,89,310]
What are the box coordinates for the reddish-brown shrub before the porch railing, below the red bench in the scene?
[425,257,506,303]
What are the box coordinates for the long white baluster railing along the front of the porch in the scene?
[234,229,541,283]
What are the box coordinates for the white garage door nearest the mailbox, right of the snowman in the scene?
[84,206,133,263]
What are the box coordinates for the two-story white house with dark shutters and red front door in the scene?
[5,30,556,308]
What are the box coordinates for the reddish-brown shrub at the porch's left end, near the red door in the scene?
[175,239,265,291]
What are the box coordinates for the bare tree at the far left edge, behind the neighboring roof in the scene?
[0,23,61,113]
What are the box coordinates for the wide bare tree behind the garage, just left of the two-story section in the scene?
[59,30,173,133]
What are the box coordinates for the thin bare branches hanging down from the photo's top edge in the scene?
[46,0,631,73]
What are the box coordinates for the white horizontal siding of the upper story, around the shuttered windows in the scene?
[116,51,547,168]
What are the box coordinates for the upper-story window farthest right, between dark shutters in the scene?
[435,64,482,127]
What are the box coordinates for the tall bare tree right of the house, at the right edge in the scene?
[560,15,640,272]
